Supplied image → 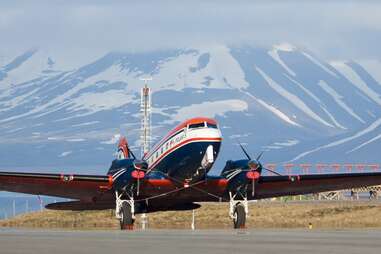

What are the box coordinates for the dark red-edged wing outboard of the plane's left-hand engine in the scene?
[0,172,112,201]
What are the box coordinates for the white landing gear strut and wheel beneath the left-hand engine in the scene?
[115,192,135,230]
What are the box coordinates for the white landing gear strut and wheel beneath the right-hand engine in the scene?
[229,192,249,229]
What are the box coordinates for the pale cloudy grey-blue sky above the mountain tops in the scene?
[0,0,381,60]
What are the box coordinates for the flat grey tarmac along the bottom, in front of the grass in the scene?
[0,228,381,254]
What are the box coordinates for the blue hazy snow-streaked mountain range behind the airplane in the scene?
[0,44,381,173]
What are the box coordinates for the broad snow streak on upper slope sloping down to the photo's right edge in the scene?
[330,61,381,105]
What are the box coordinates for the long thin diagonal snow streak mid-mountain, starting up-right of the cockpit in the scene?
[255,67,333,127]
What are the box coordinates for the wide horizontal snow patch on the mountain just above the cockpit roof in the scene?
[166,100,248,123]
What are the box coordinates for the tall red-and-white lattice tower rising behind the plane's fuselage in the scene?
[140,78,152,158]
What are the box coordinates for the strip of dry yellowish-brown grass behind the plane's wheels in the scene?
[0,201,381,229]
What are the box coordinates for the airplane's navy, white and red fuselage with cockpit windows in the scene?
[143,118,222,183]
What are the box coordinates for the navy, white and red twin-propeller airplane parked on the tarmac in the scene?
[0,117,381,230]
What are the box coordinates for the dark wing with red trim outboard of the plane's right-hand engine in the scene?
[249,172,381,199]
